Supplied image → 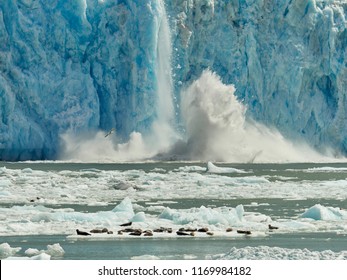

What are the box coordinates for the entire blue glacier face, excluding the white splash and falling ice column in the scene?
[0,0,347,160]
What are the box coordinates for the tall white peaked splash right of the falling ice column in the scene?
[172,70,332,162]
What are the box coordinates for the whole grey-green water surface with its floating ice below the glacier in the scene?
[0,162,347,260]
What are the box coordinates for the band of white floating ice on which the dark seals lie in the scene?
[0,197,347,238]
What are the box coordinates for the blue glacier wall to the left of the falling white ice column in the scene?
[0,0,173,160]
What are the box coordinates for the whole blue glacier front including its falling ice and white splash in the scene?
[0,0,347,162]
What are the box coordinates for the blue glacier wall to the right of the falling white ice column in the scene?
[167,0,347,154]
